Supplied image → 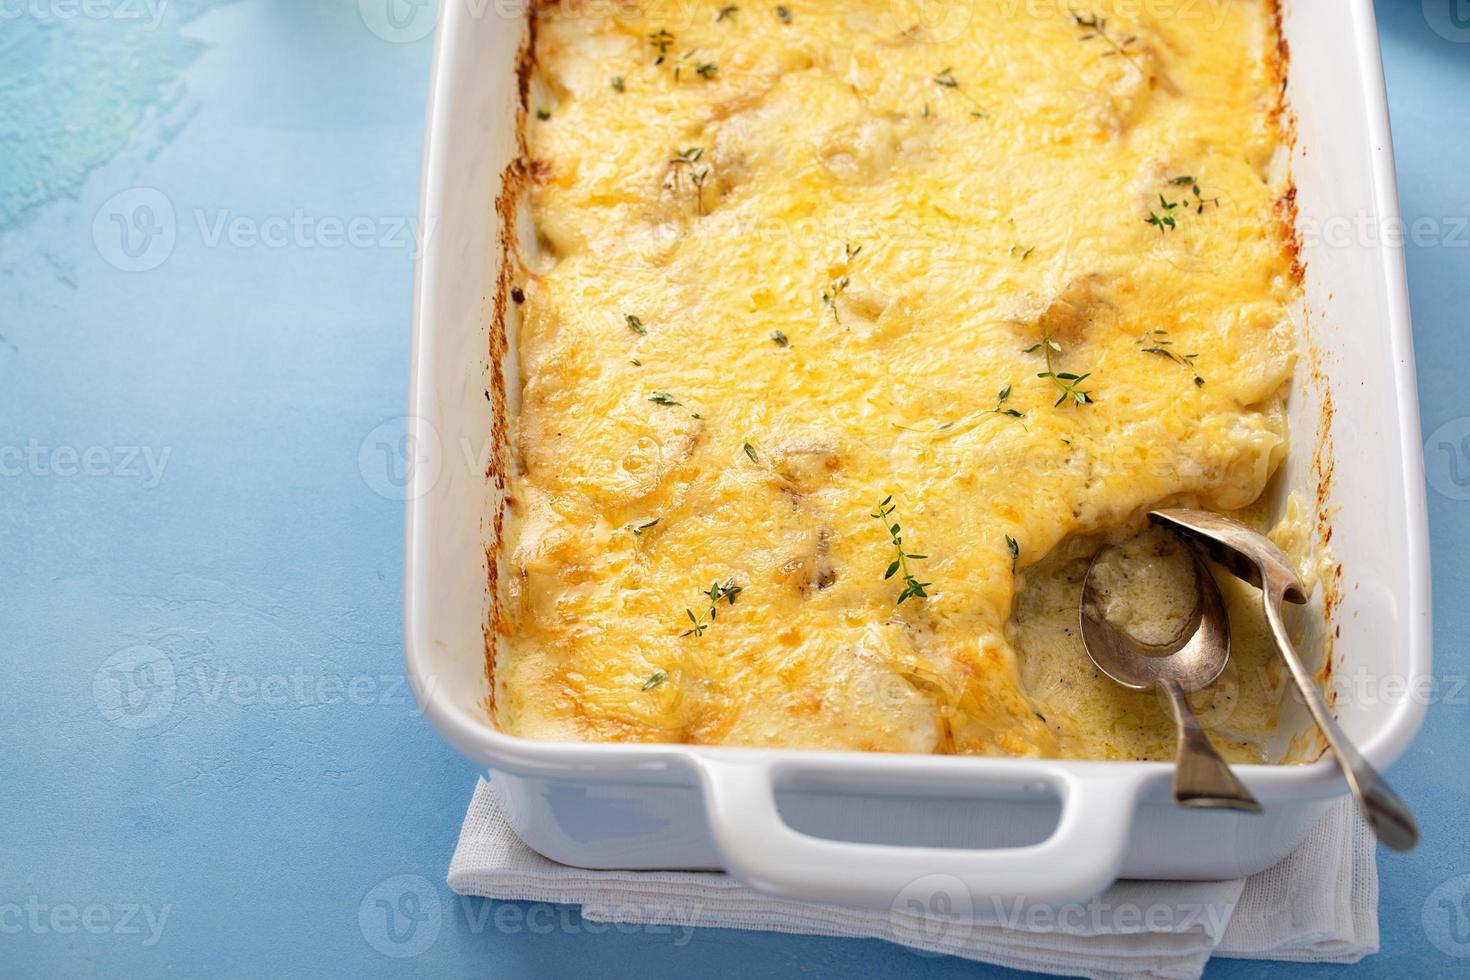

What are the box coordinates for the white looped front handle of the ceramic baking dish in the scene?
[700,758,1141,911]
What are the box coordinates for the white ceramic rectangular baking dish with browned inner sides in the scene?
[404,0,1430,907]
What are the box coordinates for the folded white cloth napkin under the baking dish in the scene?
[448,780,1379,980]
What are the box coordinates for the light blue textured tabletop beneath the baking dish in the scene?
[0,0,1470,977]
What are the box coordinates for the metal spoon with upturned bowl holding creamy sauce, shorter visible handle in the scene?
[1080,548,1261,813]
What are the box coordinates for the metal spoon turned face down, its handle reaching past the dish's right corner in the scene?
[1148,510,1419,851]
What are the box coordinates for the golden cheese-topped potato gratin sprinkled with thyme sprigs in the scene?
[490,0,1301,761]
